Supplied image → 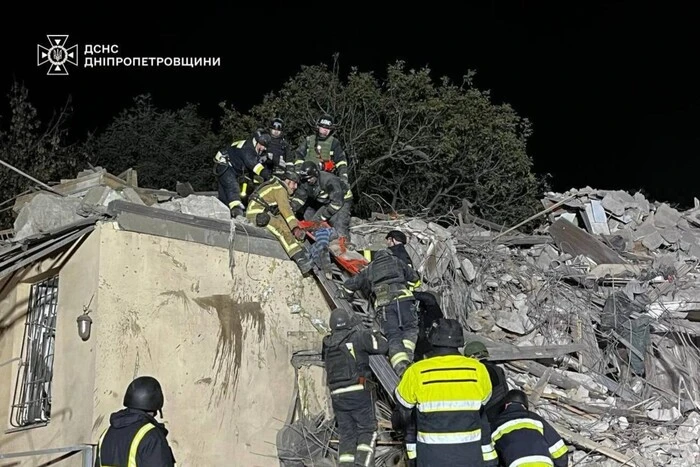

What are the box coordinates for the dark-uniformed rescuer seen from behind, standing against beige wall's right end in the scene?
[321,308,388,467]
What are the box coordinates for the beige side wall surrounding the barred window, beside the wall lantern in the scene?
[0,229,100,466]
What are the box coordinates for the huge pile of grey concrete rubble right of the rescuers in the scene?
[352,188,700,466]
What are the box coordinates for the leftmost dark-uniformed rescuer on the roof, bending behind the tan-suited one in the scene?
[214,130,272,218]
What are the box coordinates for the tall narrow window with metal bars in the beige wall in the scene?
[10,276,58,428]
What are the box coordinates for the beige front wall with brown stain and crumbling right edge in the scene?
[91,224,329,467]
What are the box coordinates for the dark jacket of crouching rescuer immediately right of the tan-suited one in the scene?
[292,172,352,221]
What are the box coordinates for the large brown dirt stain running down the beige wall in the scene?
[192,295,265,405]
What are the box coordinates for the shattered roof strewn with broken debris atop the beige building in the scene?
[0,167,288,278]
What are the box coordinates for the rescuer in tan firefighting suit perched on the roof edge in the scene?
[246,172,313,274]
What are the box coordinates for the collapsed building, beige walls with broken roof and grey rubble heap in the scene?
[0,168,700,466]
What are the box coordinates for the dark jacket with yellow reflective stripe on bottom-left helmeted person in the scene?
[95,409,175,467]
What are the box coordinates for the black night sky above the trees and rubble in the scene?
[0,0,700,207]
